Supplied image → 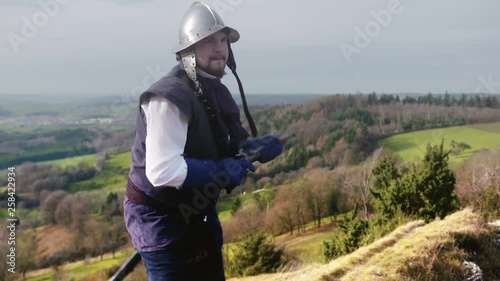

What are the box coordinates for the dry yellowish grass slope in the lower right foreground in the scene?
[229,209,500,281]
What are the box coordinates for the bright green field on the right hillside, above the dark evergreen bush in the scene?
[378,123,500,164]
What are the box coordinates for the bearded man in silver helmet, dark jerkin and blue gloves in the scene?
[124,2,283,281]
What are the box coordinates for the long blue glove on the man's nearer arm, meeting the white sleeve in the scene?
[179,158,255,190]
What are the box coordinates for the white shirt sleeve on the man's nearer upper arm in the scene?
[141,96,188,187]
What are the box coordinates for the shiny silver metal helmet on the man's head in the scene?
[173,2,240,54]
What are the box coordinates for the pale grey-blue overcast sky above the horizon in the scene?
[0,0,500,95]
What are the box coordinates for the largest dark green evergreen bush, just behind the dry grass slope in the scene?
[371,140,459,221]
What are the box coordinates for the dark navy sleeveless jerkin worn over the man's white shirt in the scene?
[124,66,248,268]
